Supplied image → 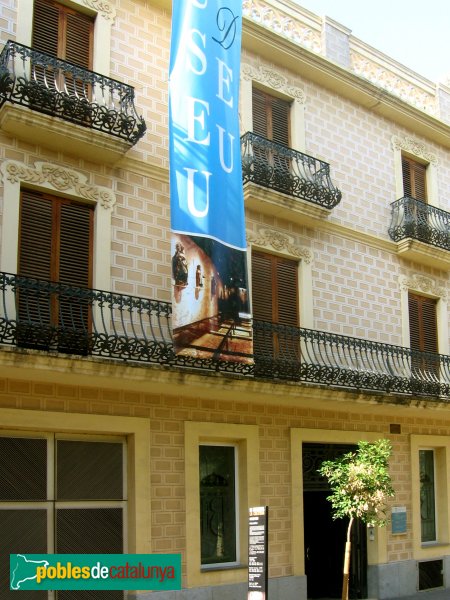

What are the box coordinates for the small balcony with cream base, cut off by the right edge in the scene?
[389,197,450,270]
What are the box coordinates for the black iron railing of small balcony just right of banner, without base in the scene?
[241,132,342,209]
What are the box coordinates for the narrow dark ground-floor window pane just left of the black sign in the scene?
[199,445,238,565]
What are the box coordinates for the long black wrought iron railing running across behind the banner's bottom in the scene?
[0,273,450,401]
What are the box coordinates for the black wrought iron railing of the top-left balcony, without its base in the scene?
[0,41,146,144]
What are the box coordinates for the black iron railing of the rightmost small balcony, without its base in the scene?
[389,196,450,250]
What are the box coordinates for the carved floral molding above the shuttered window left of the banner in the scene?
[0,160,116,209]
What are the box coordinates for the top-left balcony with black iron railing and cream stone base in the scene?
[0,41,146,163]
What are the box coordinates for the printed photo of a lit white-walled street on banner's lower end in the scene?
[172,233,252,363]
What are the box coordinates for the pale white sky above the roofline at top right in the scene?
[294,0,450,83]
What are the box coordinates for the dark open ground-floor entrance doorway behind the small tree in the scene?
[303,443,367,599]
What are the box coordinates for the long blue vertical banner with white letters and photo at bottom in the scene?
[169,0,253,363]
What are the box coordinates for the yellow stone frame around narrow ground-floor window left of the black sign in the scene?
[184,421,261,587]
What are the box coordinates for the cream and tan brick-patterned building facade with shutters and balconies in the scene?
[0,0,450,600]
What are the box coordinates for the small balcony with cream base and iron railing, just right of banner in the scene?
[241,132,342,224]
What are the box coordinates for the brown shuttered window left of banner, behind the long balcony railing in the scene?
[18,191,94,353]
